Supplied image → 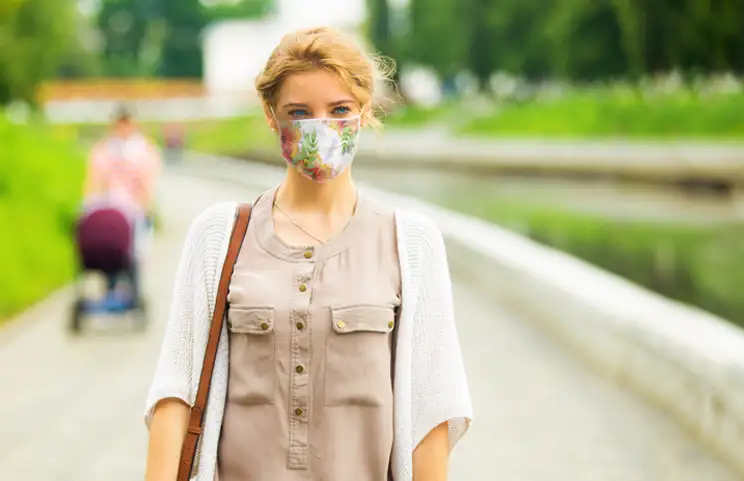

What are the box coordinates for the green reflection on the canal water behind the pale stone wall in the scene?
[445,196,744,326]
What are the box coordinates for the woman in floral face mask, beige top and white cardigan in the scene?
[146,28,471,481]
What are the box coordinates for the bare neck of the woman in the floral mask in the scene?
[276,167,357,214]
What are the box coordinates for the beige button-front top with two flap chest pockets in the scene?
[218,189,401,481]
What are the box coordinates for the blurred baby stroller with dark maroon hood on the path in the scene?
[70,204,147,334]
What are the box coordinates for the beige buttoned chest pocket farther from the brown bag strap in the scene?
[325,305,395,406]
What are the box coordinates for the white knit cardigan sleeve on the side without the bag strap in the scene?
[408,212,472,449]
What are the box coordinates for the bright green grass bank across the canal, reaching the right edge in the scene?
[458,91,744,139]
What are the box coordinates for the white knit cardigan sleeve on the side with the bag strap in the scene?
[145,211,210,428]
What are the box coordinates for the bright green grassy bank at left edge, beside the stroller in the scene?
[0,117,84,320]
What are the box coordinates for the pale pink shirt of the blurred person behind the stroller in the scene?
[85,134,160,211]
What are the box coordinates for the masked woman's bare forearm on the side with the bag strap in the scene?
[145,398,189,481]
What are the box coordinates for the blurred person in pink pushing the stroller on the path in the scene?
[83,106,161,298]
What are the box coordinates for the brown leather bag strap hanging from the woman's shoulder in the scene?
[176,204,251,481]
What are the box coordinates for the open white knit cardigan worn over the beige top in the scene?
[145,203,472,481]
